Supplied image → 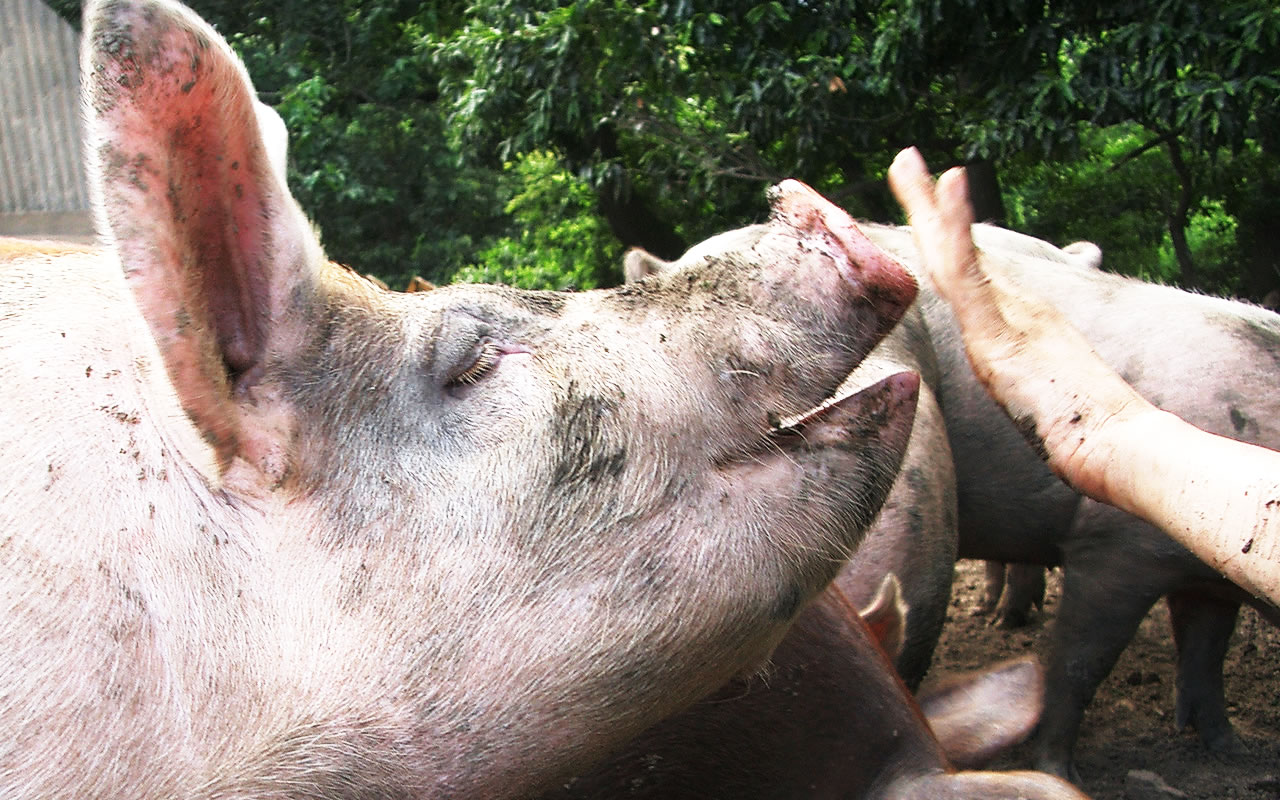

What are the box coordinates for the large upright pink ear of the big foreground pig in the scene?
[81,0,323,480]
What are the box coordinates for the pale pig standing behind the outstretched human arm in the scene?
[864,216,1280,778]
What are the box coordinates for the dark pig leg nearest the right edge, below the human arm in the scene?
[1167,590,1244,753]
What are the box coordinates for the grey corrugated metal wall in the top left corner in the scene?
[0,0,88,214]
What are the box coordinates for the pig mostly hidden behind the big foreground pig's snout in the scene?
[623,238,957,691]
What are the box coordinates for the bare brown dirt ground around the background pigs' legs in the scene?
[932,561,1280,800]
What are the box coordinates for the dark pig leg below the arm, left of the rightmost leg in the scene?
[1033,548,1164,783]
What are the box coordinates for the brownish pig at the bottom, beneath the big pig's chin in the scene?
[543,584,1084,800]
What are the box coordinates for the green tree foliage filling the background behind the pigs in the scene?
[50,0,1280,296]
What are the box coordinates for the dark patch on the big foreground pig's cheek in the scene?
[552,381,627,486]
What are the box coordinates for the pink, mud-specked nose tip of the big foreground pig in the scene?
[769,179,916,330]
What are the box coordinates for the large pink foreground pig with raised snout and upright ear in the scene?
[0,0,918,800]
